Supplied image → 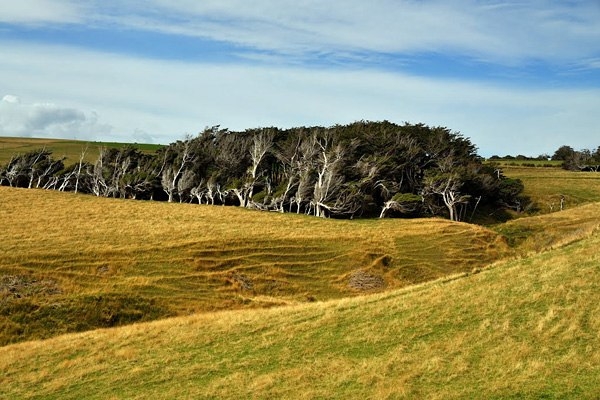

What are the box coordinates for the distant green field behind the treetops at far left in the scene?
[0,137,162,165]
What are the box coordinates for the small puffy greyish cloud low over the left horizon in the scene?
[0,94,111,140]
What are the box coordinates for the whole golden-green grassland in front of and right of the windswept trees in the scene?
[0,138,600,399]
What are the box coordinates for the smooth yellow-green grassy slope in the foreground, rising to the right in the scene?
[0,211,600,399]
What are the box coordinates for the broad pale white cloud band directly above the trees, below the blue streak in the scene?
[0,42,600,155]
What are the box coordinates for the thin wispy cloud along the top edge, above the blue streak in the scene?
[78,0,600,64]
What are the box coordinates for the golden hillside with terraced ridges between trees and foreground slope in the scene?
[0,187,511,344]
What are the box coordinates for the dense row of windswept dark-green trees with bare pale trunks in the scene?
[0,121,526,221]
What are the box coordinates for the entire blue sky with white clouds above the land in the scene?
[0,0,600,157]
